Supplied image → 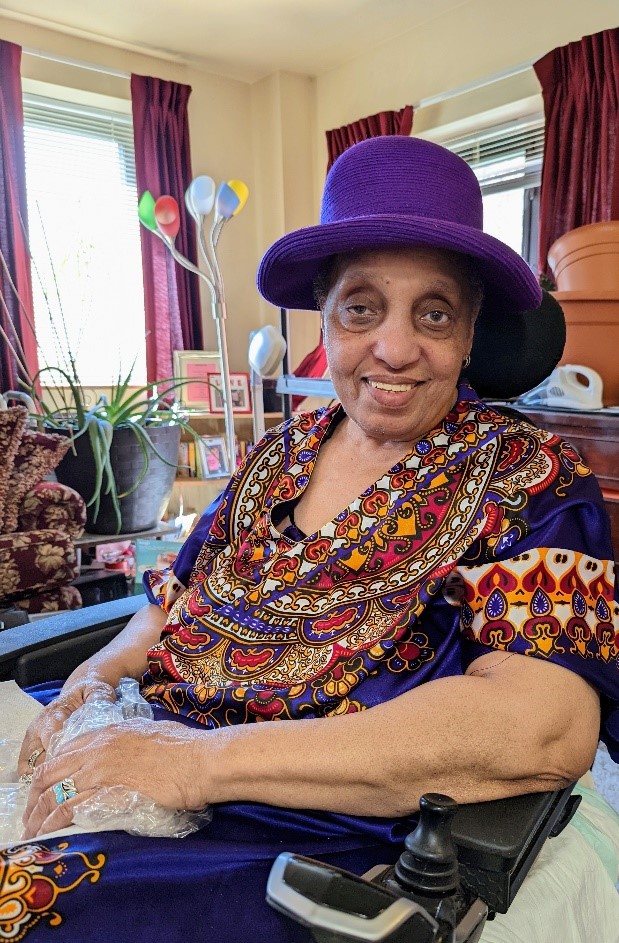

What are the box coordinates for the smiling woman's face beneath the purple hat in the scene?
[323,248,479,444]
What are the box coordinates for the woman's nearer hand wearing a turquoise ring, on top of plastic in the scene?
[23,720,209,838]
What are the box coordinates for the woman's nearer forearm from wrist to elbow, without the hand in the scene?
[205,656,599,816]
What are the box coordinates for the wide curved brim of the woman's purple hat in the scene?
[257,215,542,317]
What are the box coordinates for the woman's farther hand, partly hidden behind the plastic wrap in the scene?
[17,677,116,776]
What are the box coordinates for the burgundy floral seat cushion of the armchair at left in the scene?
[0,529,79,605]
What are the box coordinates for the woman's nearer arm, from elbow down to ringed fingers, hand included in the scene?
[25,652,599,837]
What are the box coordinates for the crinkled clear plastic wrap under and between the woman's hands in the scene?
[0,678,212,842]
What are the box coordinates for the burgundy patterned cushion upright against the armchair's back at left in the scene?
[2,429,71,534]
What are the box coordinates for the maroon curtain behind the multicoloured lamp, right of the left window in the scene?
[131,75,202,382]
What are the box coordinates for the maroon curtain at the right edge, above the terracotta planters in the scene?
[534,28,619,275]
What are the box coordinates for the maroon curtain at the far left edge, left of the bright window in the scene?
[0,40,38,391]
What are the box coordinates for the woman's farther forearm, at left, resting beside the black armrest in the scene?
[65,605,167,688]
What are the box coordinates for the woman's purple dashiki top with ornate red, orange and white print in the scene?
[143,384,619,760]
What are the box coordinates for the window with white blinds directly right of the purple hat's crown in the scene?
[445,118,544,273]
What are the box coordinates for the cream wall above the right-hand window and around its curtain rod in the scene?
[316,0,619,181]
